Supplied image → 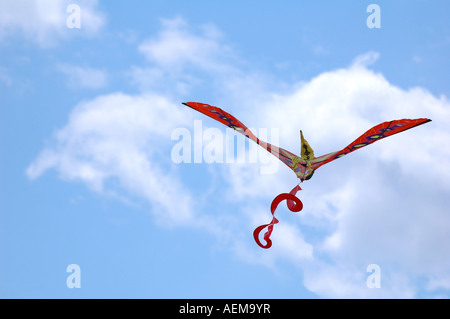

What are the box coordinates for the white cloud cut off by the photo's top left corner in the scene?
[0,0,105,47]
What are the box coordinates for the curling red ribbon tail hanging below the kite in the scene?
[253,185,303,249]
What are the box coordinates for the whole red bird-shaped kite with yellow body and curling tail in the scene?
[183,102,431,248]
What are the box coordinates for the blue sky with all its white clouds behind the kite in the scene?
[0,0,450,298]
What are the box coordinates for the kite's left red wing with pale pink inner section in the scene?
[183,102,303,173]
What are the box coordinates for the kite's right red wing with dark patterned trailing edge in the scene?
[311,118,431,169]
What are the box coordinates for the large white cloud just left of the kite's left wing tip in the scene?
[27,93,192,223]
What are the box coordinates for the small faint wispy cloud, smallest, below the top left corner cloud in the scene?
[57,64,108,89]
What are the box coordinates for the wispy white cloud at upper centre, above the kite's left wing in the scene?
[130,17,251,96]
